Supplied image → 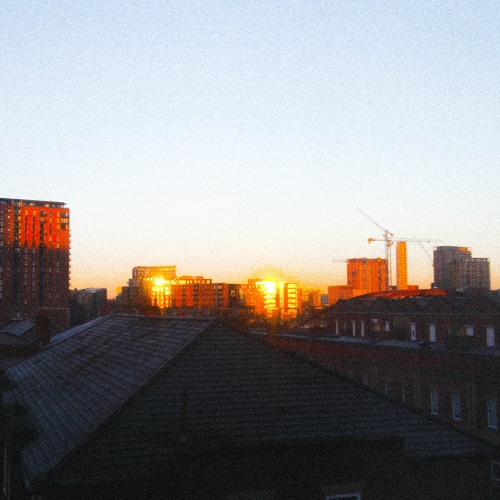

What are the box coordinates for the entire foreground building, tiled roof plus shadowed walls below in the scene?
[2,315,497,500]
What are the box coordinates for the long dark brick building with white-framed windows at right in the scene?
[276,296,500,445]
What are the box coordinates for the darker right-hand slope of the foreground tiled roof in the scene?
[50,325,490,483]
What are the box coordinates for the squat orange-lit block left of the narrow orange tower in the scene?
[347,258,387,293]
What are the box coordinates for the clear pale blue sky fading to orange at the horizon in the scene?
[0,0,500,296]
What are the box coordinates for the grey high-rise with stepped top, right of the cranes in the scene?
[433,246,490,291]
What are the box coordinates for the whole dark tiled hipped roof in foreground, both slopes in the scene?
[4,317,491,492]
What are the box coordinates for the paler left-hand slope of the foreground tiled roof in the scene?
[3,316,215,490]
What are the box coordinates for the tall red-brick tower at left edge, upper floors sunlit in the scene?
[0,198,70,330]
